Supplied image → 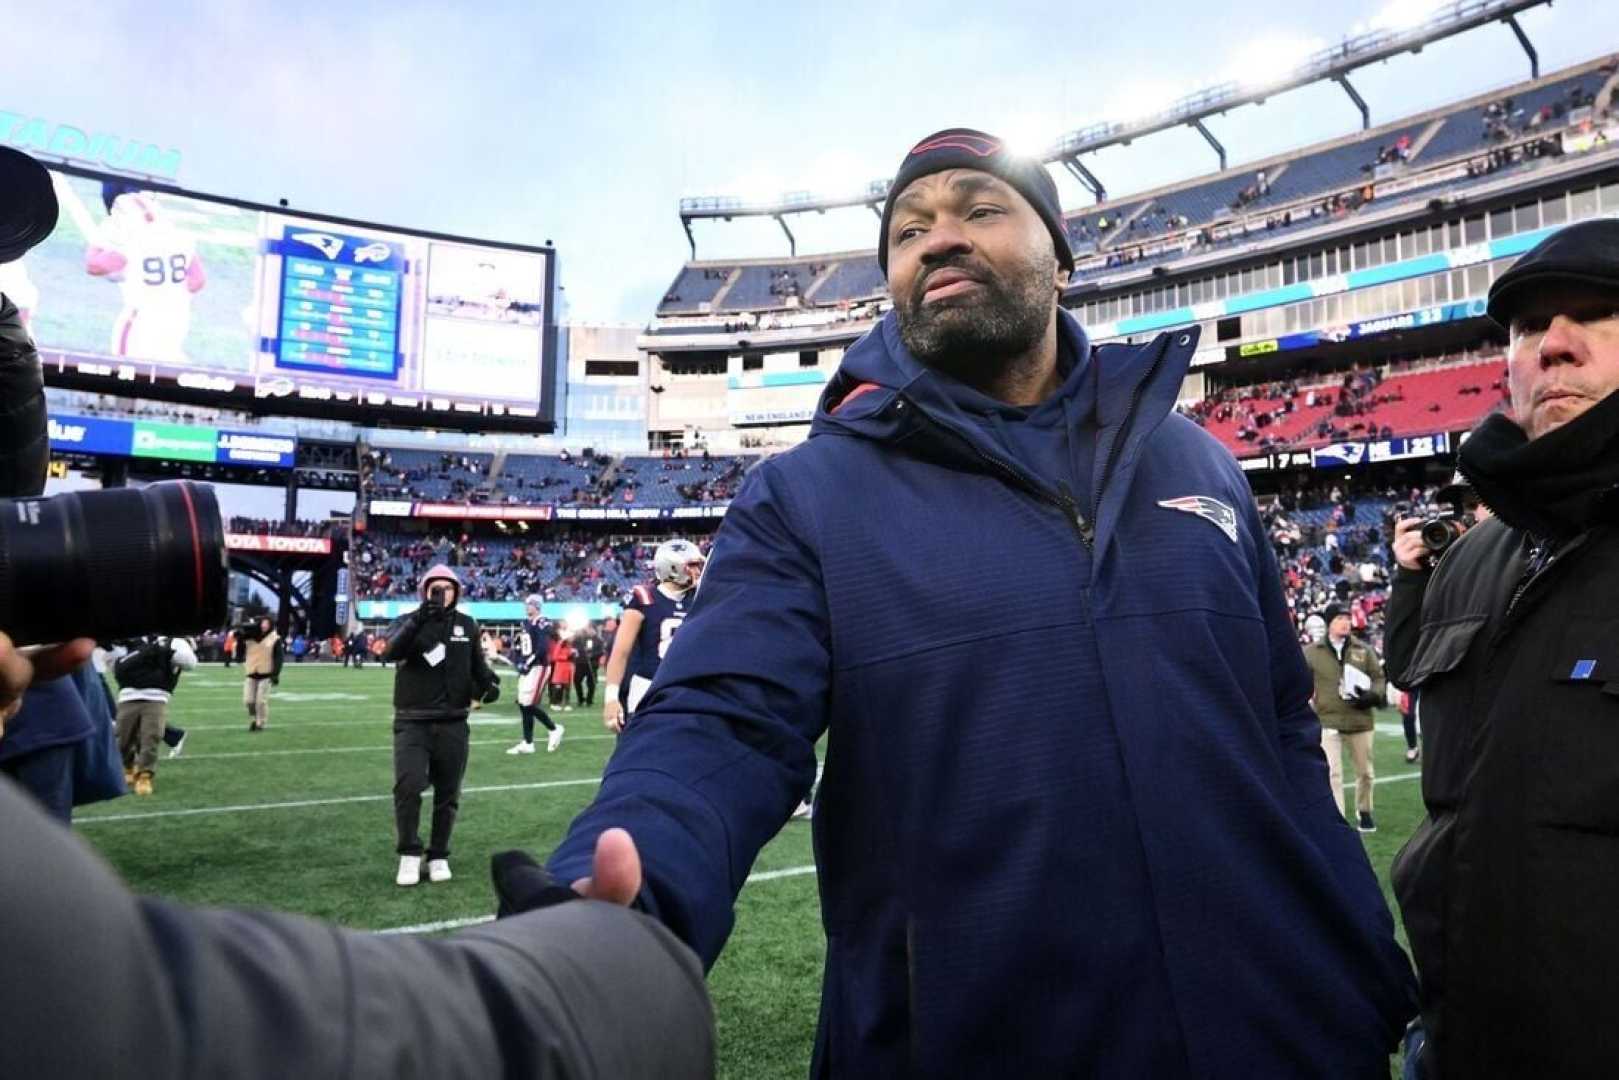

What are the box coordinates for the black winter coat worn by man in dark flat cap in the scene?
[1387,520,1619,1078]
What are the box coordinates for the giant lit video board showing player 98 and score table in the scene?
[9,165,557,432]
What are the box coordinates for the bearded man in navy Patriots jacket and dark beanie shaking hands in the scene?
[549,130,1415,1078]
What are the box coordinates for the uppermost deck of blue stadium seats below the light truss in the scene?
[649,55,1619,337]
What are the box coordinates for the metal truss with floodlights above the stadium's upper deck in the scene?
[680,0,1553,259]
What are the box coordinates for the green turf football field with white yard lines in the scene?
[76,664,1420,1078]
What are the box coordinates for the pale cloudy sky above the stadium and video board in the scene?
[0,0,1619,322]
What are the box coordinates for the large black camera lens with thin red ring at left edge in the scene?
[0,481,227,644]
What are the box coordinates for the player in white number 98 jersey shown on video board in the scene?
[84,180,207,363]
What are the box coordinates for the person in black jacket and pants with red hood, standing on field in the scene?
[382,567,500,886]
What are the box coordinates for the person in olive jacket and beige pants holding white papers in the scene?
[1305,604,1386,832]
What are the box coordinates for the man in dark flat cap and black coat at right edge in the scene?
[1387,220,1619,1080]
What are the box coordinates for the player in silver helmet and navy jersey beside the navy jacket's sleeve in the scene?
[602,539,704,733]
